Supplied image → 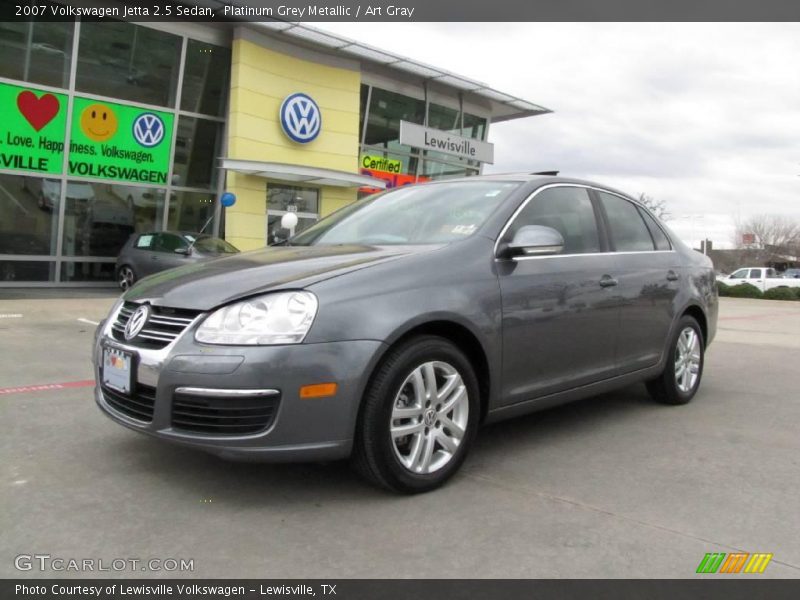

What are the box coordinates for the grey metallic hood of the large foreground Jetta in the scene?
[124,245,441,310]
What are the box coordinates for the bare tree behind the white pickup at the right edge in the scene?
[734,215,800,262]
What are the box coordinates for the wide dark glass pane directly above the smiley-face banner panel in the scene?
[75,21,181,107]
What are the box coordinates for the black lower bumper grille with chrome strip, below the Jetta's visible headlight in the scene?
[172,394,280,435]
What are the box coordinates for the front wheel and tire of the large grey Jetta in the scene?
[352,336,480,494]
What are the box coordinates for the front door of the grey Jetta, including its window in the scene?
[496,185,619,404]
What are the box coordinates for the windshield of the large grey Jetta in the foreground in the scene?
[289,180,520,246]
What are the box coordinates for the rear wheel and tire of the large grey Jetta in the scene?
[646,315,705,405]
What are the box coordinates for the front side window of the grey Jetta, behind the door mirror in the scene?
[506,187,600,254]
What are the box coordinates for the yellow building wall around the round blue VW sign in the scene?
[225,39,361,250]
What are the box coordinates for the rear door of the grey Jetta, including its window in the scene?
[596,190,686,373]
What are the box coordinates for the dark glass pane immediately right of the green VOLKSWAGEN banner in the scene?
[172,117,222,188]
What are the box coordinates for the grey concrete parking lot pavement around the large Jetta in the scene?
[0,293,800,578]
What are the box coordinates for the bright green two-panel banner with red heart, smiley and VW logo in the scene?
[0,83,174,185]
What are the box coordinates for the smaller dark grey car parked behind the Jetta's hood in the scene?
[116,231,239,291]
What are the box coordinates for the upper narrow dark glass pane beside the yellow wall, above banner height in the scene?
[181,40,231,117]
